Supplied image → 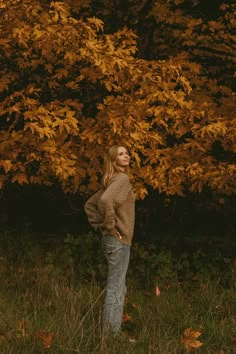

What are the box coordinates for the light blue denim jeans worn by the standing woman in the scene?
[102,235,130,333]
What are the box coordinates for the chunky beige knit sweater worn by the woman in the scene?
[84,172,135,245]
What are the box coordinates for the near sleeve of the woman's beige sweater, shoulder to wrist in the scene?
[98,173,131,235]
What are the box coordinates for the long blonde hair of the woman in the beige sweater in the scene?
[102,145,128,187]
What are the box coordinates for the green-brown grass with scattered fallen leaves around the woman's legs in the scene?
[0,233,236,354]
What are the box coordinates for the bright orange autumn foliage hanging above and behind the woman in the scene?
[0,0,236,198]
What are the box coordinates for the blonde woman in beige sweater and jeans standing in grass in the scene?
[85,145,135,334]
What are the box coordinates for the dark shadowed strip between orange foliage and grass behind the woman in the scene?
[0,184,236,248]
